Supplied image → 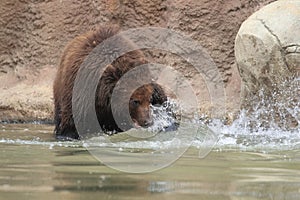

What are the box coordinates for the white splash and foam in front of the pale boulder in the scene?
[211,76,300,148]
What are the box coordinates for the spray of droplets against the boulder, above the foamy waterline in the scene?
[242,77,300,133]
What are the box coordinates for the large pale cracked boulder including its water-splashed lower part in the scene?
[235,0,300,129]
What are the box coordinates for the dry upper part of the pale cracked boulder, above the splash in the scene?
[235,0,300,104]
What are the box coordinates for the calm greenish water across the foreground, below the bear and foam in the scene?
[0,124,300,200]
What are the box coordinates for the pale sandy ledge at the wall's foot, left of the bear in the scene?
[0,67,56,122]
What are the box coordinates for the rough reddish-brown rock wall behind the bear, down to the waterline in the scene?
[0,0,276,121]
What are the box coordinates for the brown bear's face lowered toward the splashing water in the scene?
[129,84,154,127]
